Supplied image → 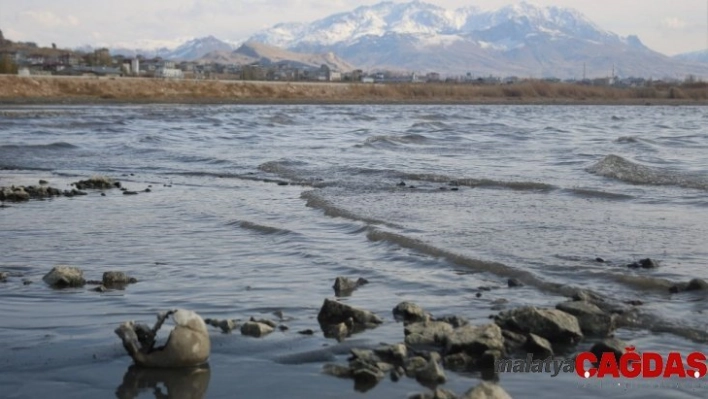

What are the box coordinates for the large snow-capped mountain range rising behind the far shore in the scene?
[249,0,708,79]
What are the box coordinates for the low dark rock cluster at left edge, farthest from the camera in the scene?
[0,176,121,202]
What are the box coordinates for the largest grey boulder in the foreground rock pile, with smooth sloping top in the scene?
[495,306,583,344]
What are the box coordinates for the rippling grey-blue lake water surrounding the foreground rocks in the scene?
[0,105,708,398]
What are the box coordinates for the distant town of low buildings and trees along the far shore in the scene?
[0,32,697,87]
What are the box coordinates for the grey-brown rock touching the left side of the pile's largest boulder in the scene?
[443,324,504,357]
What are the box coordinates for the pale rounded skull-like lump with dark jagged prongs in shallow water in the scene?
[115,309,211,368]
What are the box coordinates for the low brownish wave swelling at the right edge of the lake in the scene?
[586,154,708,190]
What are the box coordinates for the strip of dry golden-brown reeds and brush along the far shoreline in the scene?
[0,75,708,105]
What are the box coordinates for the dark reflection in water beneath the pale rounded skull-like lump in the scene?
[116,365,211,399]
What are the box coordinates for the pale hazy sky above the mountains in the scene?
[0,0,708,55]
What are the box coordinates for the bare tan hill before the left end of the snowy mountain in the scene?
[199,42,356,71]
